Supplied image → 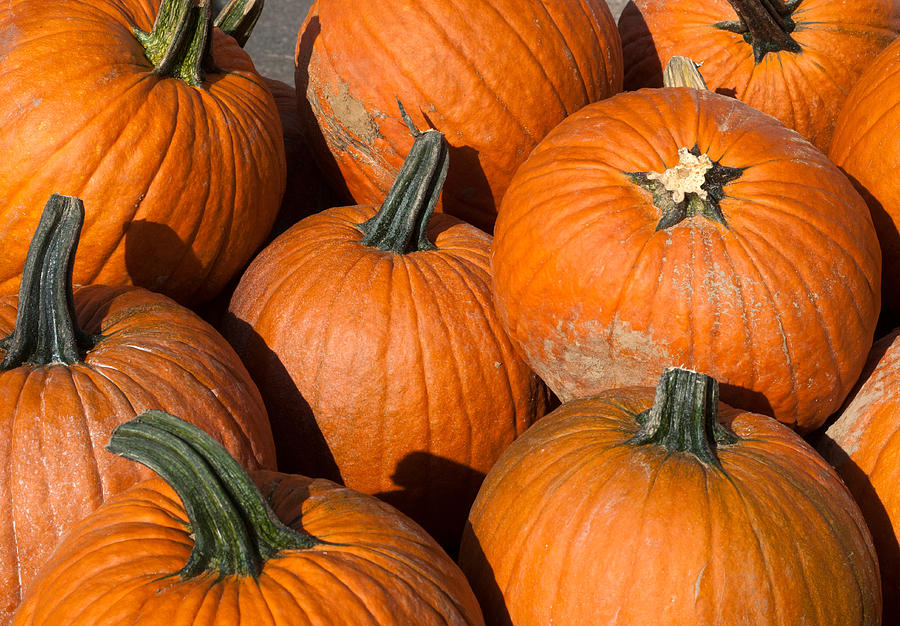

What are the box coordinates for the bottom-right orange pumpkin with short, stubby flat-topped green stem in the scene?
[459,368,882,626]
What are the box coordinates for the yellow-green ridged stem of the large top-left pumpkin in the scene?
[133,0,212,87]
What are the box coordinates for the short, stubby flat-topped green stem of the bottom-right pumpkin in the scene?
[627,367,738,468]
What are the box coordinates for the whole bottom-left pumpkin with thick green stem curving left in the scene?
[14,411,484,626]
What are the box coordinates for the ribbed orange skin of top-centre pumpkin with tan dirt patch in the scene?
[295,0,622,229]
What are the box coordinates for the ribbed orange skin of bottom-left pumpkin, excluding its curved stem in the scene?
[13,472,484,626]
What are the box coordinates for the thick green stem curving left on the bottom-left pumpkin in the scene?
[106,410,321,578]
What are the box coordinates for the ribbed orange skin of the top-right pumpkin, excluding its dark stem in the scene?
[619,0,900,150]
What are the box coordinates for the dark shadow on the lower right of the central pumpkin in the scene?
[375,451,485,559]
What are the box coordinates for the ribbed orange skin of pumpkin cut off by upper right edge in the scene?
[828,36,900,316]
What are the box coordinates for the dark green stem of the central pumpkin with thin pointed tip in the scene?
[359,102,450,254]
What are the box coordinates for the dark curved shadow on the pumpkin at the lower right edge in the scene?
[815,433,900,624]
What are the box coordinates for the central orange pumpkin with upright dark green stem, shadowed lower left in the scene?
[222,114,545,550]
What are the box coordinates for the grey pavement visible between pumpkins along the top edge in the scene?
[236,0,627,85]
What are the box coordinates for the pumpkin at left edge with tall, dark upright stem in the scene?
[0,196,275,624]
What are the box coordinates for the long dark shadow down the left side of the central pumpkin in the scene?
[219,312,344,484]
